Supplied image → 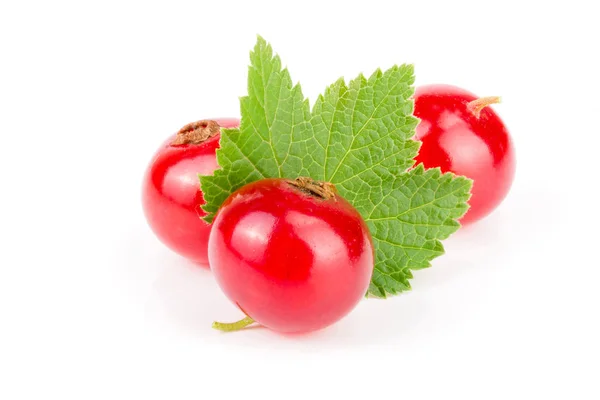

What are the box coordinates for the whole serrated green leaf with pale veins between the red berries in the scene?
[200,37,471,297]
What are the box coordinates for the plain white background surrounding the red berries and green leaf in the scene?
[0,0,600,400]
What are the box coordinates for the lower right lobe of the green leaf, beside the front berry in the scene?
[363,164,472,297]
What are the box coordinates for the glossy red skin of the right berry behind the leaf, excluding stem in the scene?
[414,85,515,225]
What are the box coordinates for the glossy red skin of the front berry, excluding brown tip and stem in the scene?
[208,179,374,333]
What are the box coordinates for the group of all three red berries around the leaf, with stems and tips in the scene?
[143,85,515,332]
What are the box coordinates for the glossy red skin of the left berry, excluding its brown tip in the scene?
[142,118,239,264]
